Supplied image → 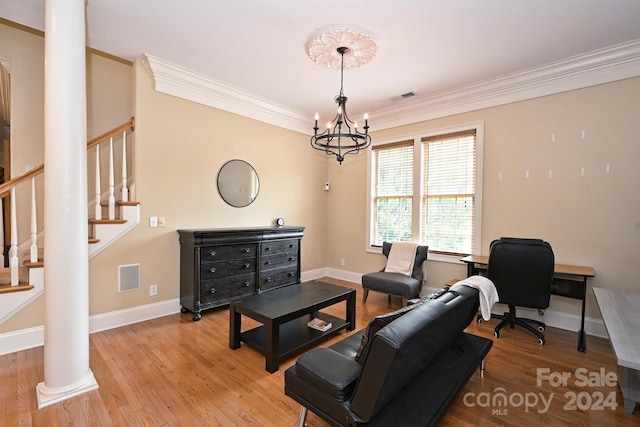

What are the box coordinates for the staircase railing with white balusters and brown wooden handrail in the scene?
[0,117,135,287]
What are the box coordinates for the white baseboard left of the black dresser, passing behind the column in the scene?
[0,298,180,356]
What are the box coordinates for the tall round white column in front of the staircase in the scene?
[37,0,98,408]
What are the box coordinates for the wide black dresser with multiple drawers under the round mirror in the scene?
[178,227,304,321]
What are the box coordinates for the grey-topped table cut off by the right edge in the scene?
[593,288,640,414]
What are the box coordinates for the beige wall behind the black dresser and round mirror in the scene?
[84,62,327,314]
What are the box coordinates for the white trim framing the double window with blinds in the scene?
[365,121,484,263]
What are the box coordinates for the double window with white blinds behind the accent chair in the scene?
[368,123,483,259]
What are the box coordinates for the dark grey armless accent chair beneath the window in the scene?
[362,242,429,306]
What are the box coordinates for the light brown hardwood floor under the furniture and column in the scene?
[0,280,640,427]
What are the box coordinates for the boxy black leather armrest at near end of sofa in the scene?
[296,347,362,401]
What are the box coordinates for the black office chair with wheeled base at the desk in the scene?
[487,237,555,344]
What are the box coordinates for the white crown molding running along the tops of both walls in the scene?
[143,39,640,134]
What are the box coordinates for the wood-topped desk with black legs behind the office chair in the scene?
[460,255,596,353]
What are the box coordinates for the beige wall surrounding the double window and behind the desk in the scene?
[327,78,640,318]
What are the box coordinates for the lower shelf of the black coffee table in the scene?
[240,312,349,359]
